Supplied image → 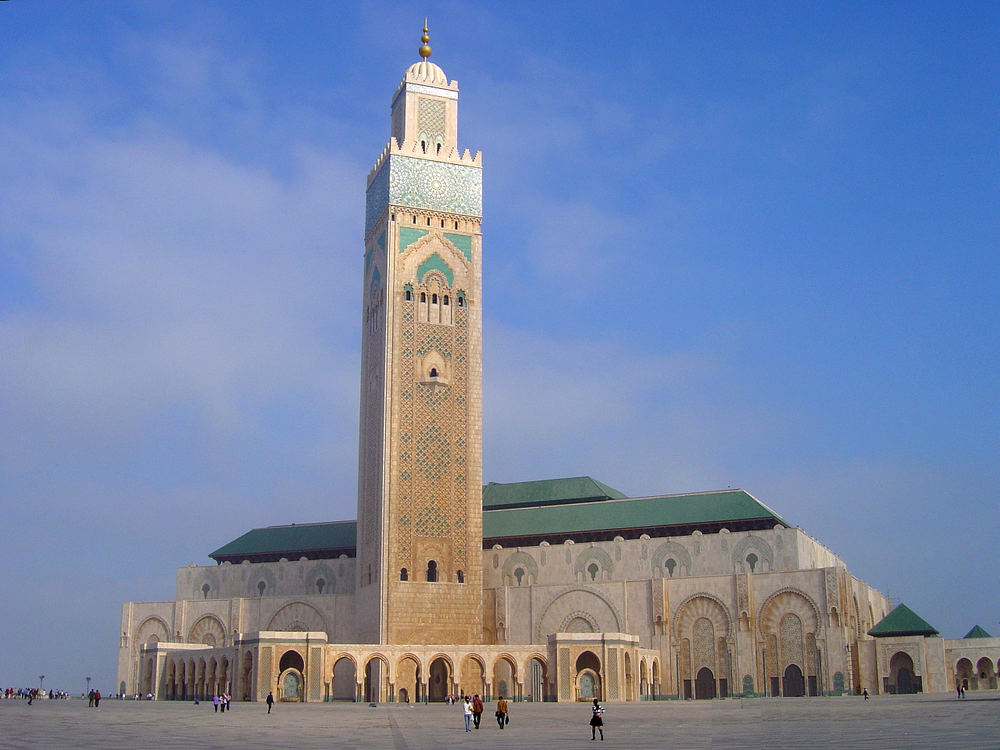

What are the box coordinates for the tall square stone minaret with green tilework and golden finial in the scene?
[356,25,483,643]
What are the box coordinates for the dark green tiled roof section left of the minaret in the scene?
[209,521,358,562]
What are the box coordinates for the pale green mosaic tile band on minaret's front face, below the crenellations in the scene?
[386,154,483,217]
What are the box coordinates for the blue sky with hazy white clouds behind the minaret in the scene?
[0,0,1000,690]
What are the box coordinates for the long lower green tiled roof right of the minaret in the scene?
[483,490,788,539]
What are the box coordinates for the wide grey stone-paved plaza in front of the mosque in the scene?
[0,692,1000,750]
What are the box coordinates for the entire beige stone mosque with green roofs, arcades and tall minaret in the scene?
[118,26,1000,702]
